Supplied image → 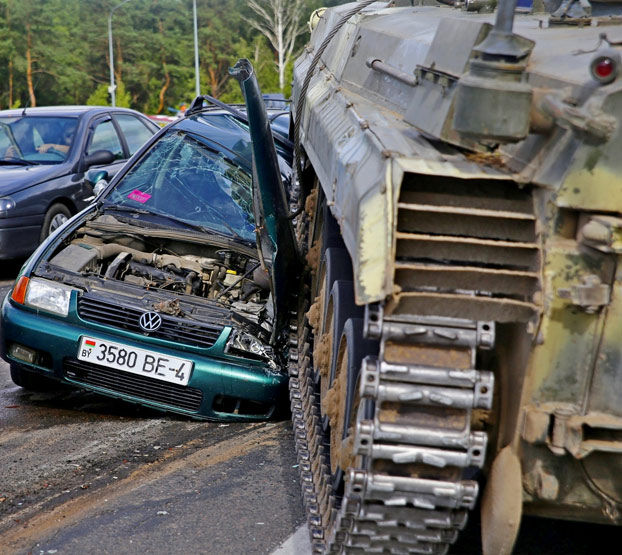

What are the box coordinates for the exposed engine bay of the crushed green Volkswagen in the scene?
[37,215,273,335]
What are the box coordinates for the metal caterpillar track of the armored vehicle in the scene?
[290,300,494,555]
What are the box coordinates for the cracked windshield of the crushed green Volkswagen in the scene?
[105,131,255,242]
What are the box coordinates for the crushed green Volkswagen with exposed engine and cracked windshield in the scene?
[0,92,292,420]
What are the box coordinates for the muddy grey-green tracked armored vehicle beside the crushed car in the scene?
[290,0,622,554]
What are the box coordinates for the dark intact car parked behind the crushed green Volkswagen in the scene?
[0,106,158,259]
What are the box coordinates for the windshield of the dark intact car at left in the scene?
[0,115,78,164]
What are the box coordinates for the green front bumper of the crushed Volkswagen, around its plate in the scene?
[0,296,287,421]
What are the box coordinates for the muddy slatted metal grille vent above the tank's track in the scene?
[393,174,541,322]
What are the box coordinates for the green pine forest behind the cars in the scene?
[0,0,342,115]
